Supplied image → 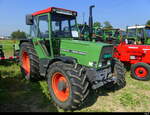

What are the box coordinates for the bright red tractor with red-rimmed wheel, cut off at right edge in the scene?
[114,42,150,81]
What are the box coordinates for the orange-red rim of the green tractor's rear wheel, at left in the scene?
[22,52,30,75]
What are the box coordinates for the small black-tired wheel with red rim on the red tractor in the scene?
[131,63,150,81]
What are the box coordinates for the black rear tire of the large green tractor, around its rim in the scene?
[19,42,41,81]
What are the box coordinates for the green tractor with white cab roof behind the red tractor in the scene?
[126,25,150,44]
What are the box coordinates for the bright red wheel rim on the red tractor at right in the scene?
[135,67,148,78]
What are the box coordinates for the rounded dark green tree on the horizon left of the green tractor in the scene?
[11,30,26,39]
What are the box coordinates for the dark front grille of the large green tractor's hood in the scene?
[99,46,113,66]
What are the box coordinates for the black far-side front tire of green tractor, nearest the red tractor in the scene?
[106,58,126,89]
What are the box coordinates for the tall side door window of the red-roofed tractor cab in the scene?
[38,15,49,38]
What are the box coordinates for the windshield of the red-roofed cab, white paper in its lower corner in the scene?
[51,14,78,38]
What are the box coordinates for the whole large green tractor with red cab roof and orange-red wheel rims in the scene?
[20,6,126,110]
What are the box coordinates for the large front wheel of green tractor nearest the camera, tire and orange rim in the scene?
[47,62,89,110]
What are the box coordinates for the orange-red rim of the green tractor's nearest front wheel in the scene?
[52,72,70,102]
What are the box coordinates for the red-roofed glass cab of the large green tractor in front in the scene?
[26,7,79,58]
